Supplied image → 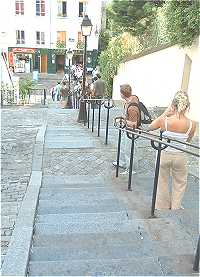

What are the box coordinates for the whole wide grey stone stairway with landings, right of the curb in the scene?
[1,104,198,276]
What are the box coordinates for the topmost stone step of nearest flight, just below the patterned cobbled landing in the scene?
[42,175,106,187]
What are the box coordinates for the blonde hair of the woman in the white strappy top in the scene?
[172,90,190,114]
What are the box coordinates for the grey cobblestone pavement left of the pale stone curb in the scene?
[1,106,47,261]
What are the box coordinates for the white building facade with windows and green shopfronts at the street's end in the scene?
[0,0,102,73]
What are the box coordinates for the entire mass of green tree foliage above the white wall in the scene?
[99,0,200,95]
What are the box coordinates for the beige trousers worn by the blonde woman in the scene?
[155,151,187,210]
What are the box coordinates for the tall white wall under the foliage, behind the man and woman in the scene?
[113,43,200,121]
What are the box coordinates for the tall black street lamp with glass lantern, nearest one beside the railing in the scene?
[78,15,92,123]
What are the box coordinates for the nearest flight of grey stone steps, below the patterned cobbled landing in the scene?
[28,175,198,276]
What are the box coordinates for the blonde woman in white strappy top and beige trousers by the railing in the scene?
[148,91,196,210]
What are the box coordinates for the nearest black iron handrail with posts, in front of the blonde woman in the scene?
[114,118,200,271]
